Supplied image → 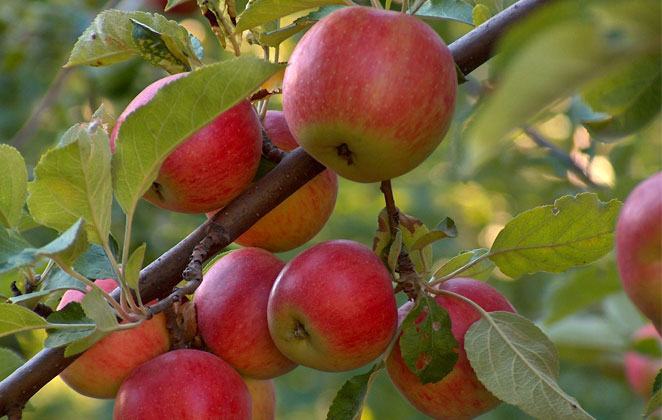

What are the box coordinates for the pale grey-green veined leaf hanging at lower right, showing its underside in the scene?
[464,311,593,420]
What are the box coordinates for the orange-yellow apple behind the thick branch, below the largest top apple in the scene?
[235,111,338,252]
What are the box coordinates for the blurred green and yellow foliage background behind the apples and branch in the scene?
[0,0,662,420]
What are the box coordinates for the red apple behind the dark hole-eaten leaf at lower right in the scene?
[386,277,515,420]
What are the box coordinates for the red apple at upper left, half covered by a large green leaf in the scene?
[110,73,262,213]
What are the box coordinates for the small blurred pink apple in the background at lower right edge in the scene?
[624,324,662,401]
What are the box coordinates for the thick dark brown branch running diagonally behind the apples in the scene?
[0,0,551,415]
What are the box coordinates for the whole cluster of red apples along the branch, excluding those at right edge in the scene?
[61,7,536,420]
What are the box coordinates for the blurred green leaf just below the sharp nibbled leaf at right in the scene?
[545,265,622,324]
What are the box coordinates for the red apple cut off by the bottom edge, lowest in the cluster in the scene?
[113,349,251,420]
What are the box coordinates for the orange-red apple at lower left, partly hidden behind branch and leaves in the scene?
[57,279,170,398]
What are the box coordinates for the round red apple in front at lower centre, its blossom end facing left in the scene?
[267,240,397,372]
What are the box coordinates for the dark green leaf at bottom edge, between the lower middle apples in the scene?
[326,361,385,420]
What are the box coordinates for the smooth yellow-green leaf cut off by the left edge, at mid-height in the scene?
[0,144,28,229]
